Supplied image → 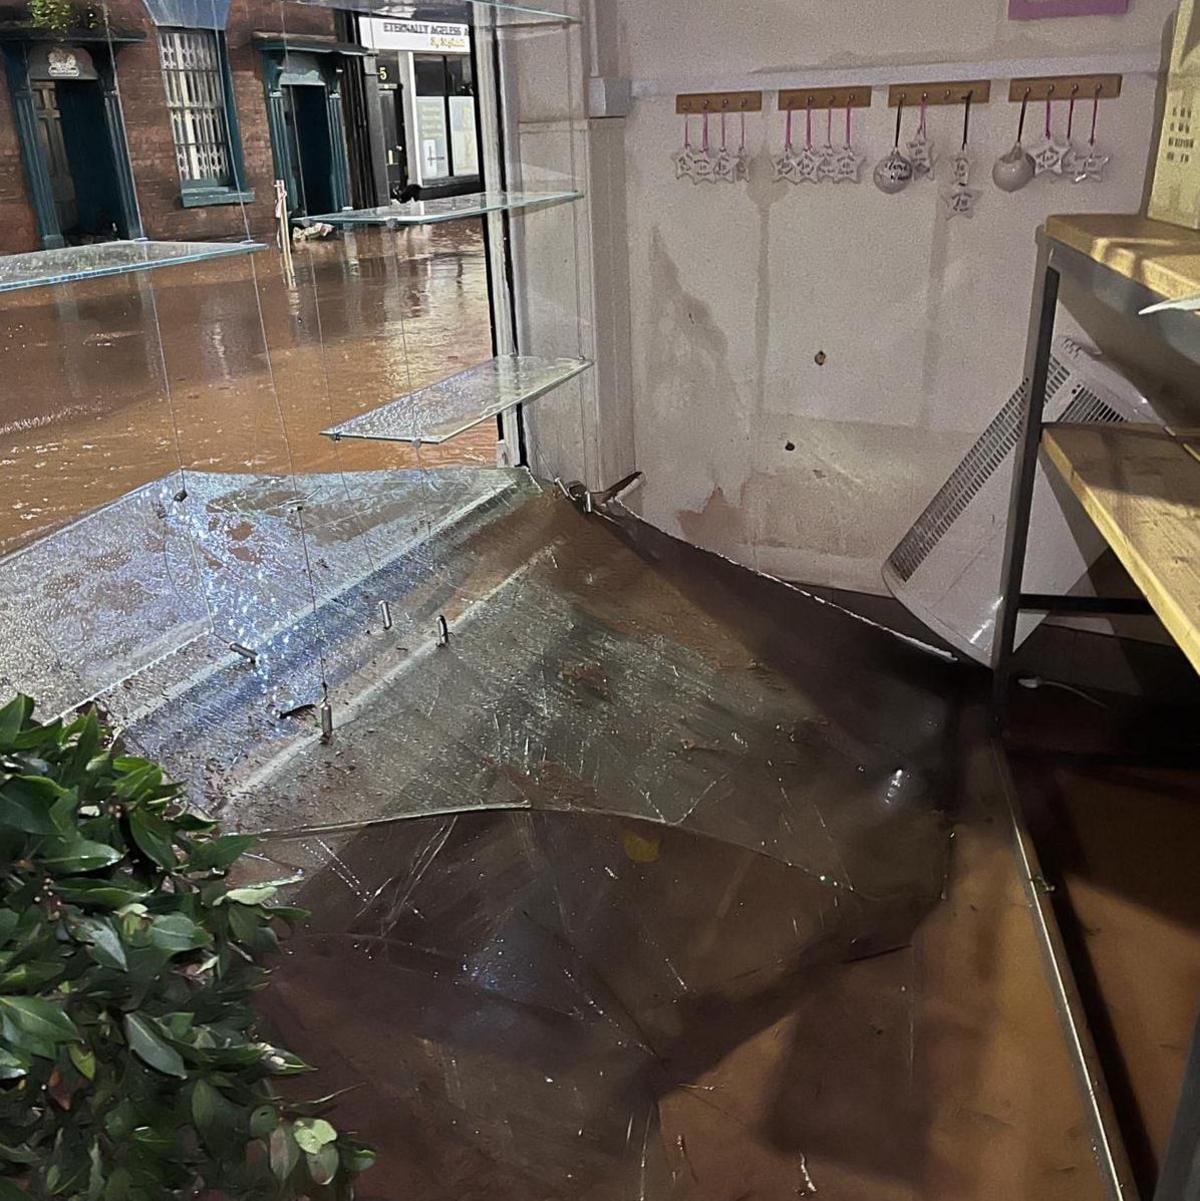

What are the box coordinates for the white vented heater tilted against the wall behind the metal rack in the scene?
[883,336,1162,663]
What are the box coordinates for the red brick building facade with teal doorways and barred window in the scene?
[0,0,362,253]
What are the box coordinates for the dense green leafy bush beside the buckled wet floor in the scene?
[0,697,374,1201]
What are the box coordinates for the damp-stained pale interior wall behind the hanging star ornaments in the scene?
[610,0,1175,592]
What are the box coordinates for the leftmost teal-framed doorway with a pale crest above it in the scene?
[4,30,142,249]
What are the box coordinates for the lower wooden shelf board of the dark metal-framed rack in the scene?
[1043,425,1200,671]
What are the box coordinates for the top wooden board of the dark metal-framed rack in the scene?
[1046,213,1200,300]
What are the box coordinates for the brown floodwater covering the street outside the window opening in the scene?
[0,221,496,552]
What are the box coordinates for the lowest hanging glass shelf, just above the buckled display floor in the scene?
[321,354,591,443]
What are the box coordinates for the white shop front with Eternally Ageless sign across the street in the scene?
[360,17,480,198]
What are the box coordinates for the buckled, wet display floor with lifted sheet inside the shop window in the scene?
[0,470,1124,1201]
